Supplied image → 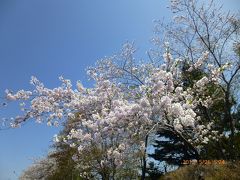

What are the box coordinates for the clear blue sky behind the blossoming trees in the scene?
[0,0,240,180]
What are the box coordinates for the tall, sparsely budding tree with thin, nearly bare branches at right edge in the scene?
[149,0,240,158]
